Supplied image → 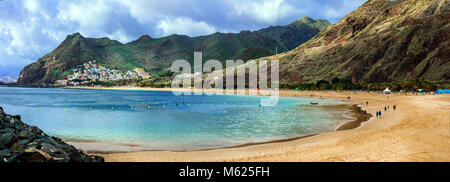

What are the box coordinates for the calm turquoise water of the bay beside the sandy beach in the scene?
[0,87,349,150]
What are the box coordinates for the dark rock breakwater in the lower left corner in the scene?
[0,107,104,162]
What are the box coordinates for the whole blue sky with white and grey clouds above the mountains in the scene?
[0,0,365,76]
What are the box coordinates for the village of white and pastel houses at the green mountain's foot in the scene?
[55,60,150,86]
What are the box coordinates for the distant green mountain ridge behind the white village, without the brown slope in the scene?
[18,17,330,84]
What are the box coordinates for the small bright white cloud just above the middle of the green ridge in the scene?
[156,17,216,36]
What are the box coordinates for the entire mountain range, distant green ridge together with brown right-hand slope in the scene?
[18,0,450,84]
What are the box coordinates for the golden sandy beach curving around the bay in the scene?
[67,87,450,162]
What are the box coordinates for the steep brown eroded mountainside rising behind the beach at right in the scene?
[264,0,450,84]
